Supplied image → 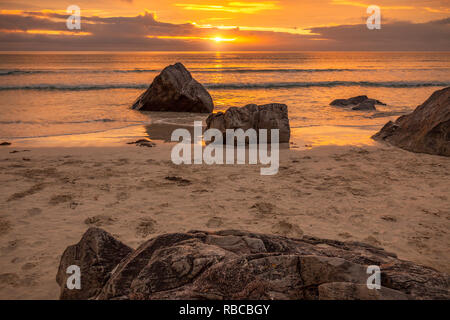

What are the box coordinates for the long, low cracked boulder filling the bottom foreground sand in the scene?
[59,230,450,299]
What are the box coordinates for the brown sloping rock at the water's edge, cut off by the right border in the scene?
[372,87,450,157]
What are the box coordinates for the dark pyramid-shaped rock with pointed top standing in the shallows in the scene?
[132,63,214,113]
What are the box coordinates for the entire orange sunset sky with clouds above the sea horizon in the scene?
[0,0,450,51]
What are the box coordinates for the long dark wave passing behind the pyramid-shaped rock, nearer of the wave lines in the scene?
[0,81,450,91]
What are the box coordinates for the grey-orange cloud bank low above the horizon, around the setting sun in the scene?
[0,11,450,51]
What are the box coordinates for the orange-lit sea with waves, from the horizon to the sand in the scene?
[0,52,450,148]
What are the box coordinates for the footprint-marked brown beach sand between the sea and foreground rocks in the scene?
[0,143,450,299]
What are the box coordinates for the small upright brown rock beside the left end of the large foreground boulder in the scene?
[56,227,133,300]
